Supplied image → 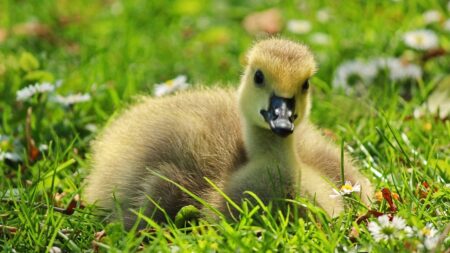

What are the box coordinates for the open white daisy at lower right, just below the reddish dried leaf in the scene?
[367,215,411,242]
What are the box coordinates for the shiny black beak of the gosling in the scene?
[260,94,297,137]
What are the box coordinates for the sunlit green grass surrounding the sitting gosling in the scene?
[0,0,450,252]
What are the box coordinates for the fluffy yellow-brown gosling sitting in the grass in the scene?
[85,38,373,227]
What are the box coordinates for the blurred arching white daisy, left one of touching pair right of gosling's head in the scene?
[333,60,378,90]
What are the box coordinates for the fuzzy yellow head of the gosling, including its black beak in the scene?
[239,38,316,137]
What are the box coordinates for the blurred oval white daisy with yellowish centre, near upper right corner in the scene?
[403,29,439,50]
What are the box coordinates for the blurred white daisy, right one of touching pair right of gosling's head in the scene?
[373,57,422,81]
